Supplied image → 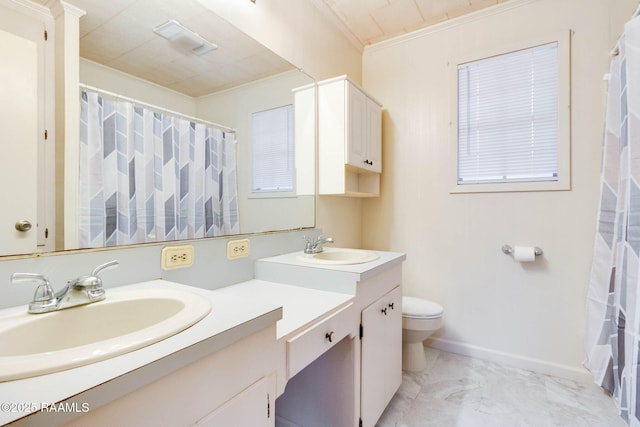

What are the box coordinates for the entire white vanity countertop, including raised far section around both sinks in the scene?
[0,252,405,425]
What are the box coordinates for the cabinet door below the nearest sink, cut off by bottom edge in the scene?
[196,374,276,427]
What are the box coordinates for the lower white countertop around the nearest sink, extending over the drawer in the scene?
[0,280,352,425]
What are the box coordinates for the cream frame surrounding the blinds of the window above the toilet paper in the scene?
[450,31,571,193]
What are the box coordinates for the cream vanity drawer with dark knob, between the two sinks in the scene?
[287,303,357,378]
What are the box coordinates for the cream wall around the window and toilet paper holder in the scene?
[362,0,637,378]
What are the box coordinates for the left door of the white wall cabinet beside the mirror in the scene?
[344,82,368,169]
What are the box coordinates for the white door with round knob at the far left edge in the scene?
[0,11,43,255]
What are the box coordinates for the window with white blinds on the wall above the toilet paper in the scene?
[456,33,569,192]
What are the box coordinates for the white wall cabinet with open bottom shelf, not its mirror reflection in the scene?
[318,76,382,197]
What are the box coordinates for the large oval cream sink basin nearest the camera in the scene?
[0,289,211,381]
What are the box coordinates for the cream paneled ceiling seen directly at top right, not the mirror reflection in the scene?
[322,0,507,45]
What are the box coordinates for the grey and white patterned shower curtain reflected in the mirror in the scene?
[79,90,240,248]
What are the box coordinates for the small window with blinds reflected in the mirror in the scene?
[251,105,295,195]
